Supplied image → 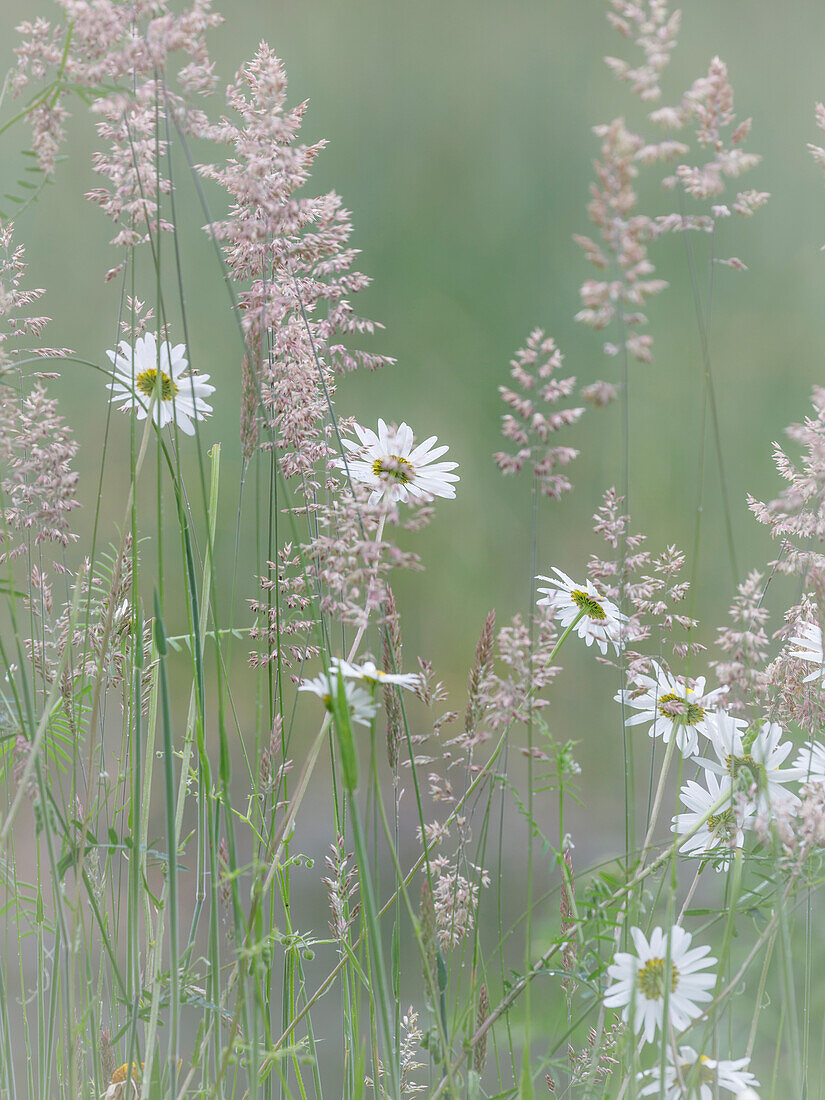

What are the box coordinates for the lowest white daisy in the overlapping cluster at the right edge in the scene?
[672,771,754,871]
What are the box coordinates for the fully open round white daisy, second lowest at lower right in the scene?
[604,924,716,1043]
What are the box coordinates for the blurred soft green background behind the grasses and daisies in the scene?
[0,0,825,1082]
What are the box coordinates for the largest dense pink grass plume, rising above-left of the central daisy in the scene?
[199,43,394,481]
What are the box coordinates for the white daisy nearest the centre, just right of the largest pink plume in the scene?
[334,420,460,504]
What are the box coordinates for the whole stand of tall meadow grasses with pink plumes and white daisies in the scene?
[0,0,825,1100]
